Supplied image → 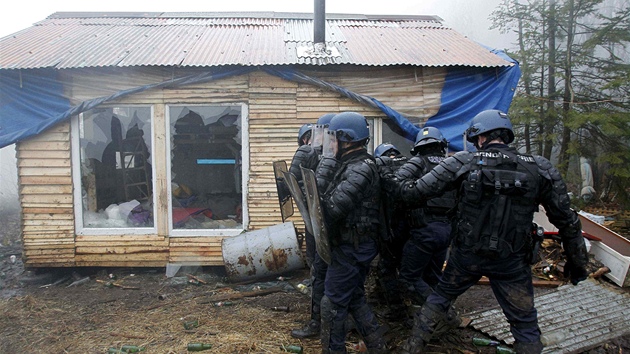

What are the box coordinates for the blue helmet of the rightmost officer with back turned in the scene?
[466,109,514,145]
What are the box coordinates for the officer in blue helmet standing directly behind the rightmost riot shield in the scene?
[316,112,387,353]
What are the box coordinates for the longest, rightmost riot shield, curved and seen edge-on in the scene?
[301,167,332,264]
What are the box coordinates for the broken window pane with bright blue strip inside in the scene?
[168,106,243,234]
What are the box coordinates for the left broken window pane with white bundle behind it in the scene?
[78,106,154,228]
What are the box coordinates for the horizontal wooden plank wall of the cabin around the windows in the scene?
[16,67,446,266]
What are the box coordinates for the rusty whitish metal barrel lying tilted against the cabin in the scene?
[221,222,305,281]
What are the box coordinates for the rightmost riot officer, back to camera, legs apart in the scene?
[386,110,588,354]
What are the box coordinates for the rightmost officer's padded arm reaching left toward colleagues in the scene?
[398,151,473,207]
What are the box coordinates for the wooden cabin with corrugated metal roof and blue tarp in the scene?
[0,13,518,267]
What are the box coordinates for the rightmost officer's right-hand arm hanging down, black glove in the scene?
[535,156,588,285]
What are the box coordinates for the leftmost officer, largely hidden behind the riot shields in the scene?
[289,113,335,339]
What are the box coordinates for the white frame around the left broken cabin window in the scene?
[70,104,157,236]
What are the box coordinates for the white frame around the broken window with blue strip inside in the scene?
[164,102,249,238]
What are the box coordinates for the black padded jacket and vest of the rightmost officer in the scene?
[400,145,588,267]
